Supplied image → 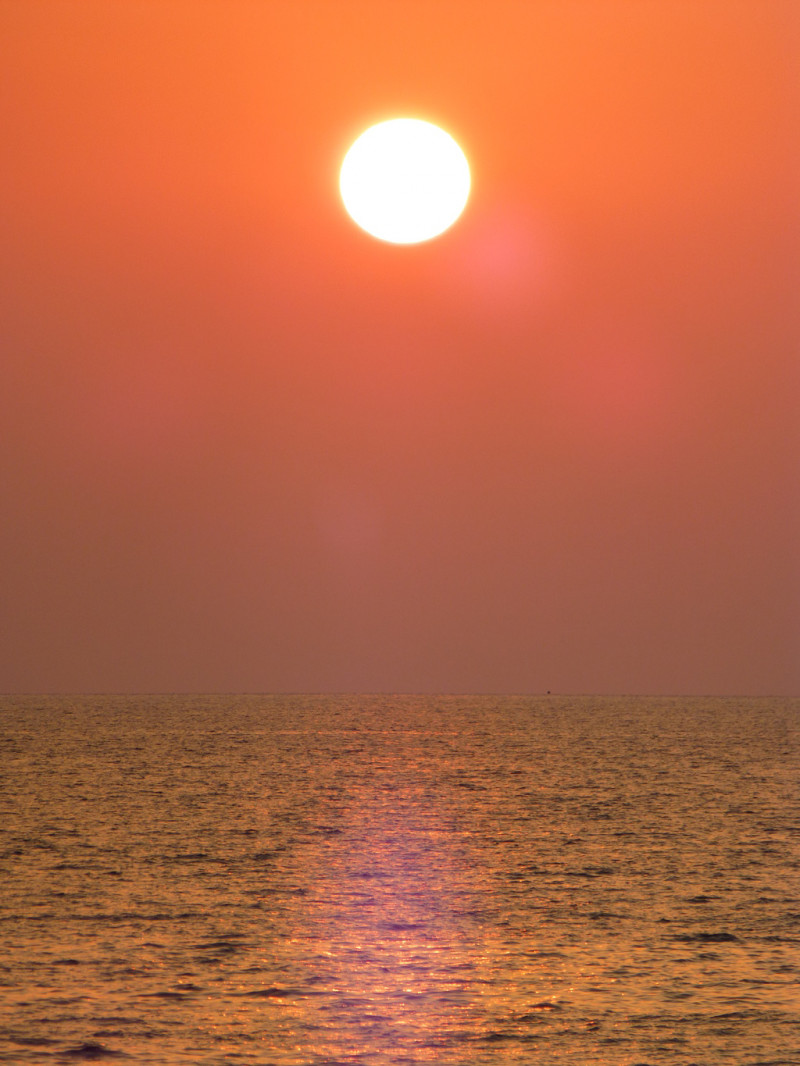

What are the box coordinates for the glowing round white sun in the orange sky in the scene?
[339,118,469,244]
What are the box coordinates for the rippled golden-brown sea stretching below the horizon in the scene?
[0,696,800,1066]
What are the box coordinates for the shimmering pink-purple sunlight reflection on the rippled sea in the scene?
[234,760,571,1061]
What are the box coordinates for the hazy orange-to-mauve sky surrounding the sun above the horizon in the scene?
[0,0,800,694]
